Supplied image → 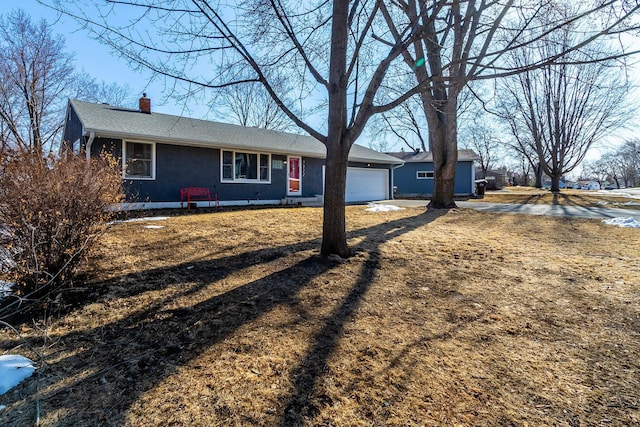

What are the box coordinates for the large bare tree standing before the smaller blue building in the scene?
[383,0,640,208]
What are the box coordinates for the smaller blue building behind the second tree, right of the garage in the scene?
[387,150,480,198]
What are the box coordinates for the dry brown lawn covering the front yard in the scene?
[0,201,640,426]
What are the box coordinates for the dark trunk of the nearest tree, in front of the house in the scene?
[320,1,353,258]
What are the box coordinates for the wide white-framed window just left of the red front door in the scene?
[222,150,271,183]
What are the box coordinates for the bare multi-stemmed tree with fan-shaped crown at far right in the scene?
[499,9,629,192]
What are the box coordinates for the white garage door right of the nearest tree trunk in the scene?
[345,168,389,202]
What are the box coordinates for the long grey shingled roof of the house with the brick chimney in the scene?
[69,99,403,164]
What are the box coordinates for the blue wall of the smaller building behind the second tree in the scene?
[393,162,473,197]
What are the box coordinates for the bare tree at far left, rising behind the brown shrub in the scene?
[0,10,74,156]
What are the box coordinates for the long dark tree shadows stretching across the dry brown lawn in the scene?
[0,211,446,425]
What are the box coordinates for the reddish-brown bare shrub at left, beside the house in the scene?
[0,152,122,305]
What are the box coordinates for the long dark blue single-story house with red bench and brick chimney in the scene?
[63,96,402,209]
